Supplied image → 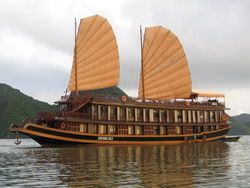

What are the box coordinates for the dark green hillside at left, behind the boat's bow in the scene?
[0,83,57,138]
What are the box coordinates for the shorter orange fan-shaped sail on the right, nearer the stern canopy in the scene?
[139,26,192,99]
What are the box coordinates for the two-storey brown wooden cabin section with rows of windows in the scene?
[53,88,227,135]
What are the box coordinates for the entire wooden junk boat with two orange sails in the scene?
[10,15,230,146]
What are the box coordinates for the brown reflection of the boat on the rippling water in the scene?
[32,142,230,187]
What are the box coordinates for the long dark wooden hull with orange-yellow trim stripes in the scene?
[10,123,230,146]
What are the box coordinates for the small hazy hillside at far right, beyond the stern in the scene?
[229,114,250,135]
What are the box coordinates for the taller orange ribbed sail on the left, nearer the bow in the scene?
[68,15,120,91]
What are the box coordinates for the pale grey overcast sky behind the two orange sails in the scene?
[0,0,250,115]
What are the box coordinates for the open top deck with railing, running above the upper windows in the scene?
[56,94,228,110]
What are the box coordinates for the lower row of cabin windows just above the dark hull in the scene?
[54,121,229,135]
